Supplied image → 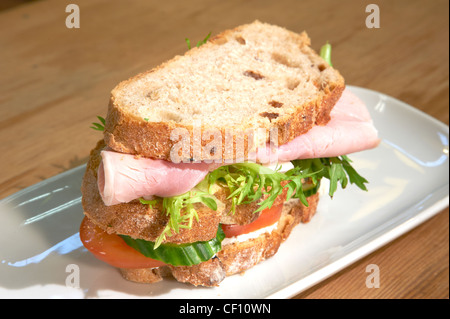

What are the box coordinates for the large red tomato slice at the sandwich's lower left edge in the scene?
[80,217,164,268]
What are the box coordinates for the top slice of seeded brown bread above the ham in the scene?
[105,21,345,161]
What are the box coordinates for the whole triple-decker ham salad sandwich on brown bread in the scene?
[80,21,379,287]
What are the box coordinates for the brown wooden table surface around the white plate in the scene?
[0,0,449,298]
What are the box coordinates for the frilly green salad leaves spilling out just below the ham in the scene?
[141,156,368,249]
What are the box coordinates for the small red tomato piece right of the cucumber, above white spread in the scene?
[222,204,283,237]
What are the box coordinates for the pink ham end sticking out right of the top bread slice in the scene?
[257,89,380,163]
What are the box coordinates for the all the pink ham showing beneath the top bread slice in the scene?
[98,89,379,206]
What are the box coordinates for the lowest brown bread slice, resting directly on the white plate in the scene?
[120,194,319,287]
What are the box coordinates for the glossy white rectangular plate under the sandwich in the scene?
[0,87,449,299]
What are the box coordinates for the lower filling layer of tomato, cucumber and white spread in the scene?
[80,195,283,269]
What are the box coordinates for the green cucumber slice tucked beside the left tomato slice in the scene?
[119,226,225,266]
